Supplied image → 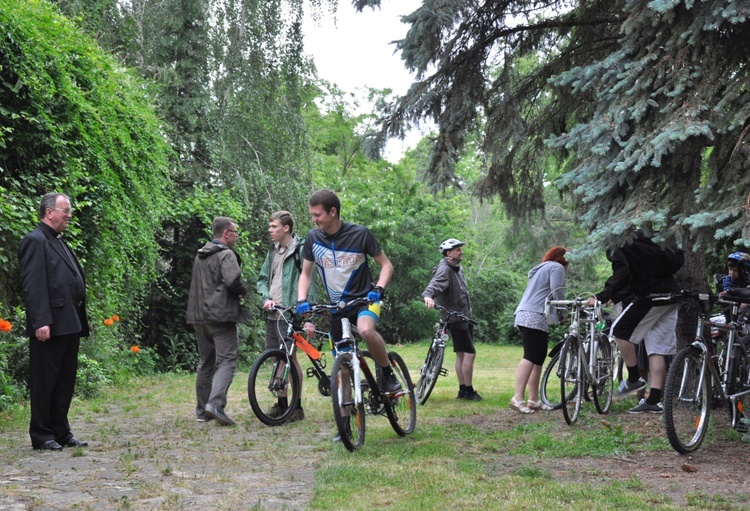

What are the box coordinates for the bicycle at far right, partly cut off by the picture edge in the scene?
[660,288,750,453]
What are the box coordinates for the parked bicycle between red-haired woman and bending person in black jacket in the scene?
[547,295,614,425]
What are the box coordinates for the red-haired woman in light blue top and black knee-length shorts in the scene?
[510,247,568,413]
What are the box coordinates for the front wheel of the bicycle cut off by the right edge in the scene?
[664,346,711,454]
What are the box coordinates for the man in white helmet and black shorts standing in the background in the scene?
[422,238,482,401]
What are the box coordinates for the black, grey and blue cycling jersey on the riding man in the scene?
[302,222,382,303]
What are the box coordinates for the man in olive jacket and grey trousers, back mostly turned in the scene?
[187,216,247,426]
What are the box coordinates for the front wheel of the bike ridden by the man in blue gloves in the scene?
[331,353,365,451]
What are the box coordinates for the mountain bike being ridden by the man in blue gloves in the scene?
[322,298,417,451]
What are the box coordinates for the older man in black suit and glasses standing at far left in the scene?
[18,193,89,451]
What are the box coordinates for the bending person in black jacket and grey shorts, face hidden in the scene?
[587,231,682,413]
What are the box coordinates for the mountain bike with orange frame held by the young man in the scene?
[247,306,331,426]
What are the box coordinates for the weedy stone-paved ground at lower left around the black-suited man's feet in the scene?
[0,392,331,511]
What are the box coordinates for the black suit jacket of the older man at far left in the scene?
[18,223,89,338]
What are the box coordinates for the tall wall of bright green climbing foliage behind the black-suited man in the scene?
[0,0,175,388]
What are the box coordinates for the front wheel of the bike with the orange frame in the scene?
[247,350,302,426]
